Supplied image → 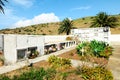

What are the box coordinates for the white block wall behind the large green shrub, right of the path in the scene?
[71,27,110,42]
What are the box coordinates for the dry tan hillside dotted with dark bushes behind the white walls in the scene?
[0,15,120,35]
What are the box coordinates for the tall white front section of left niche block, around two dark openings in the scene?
[4,35,44,64]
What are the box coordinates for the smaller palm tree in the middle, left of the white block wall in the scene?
[58,18,73,35]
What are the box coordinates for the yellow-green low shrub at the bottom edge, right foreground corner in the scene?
[76,66,113,80]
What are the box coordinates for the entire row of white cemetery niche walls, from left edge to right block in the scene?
[0,27,110,64]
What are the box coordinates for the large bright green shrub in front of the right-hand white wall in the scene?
[76,40,113,58]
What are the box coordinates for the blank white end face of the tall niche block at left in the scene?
[4,35,17,64]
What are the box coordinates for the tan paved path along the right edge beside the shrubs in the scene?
[108,44,120,80]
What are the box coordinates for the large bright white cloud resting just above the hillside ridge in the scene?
[13,13,59,27]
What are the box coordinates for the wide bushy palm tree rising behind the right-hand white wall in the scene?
[90,12,118,27]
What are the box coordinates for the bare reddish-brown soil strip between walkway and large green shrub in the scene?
[58,49,108,66]
